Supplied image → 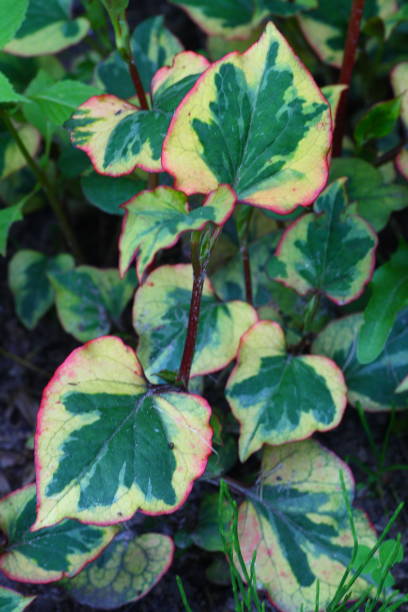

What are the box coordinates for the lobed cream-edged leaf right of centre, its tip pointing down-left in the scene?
[225,321,347,462]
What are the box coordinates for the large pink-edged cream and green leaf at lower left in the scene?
[34,336,212,529]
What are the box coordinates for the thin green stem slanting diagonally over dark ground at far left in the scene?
[0,111,84,261]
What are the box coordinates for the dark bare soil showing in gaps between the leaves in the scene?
[0,0,408,612]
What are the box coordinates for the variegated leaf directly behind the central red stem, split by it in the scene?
[133,264,257,382]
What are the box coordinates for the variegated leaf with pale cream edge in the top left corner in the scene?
[5,0,89,57]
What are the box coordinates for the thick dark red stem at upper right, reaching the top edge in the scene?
[333,0,364,157]
